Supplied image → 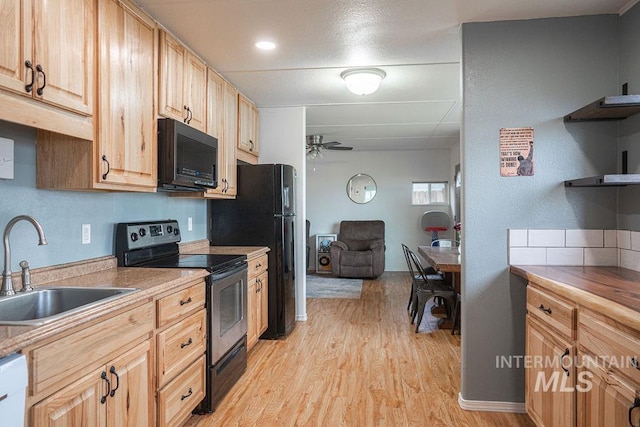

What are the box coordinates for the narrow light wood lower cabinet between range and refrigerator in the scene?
[247,254,269,350]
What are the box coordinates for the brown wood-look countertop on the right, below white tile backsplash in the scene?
[510,265,640,329]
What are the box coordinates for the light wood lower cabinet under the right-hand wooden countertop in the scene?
[525,283,640,427]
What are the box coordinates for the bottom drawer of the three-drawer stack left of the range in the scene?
[158,355,205,426]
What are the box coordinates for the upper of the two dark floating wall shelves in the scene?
[564,95,640,123]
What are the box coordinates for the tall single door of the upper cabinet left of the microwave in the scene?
[96,0,158,191]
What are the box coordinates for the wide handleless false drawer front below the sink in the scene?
[29,301,153,395]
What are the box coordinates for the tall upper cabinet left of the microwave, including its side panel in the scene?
[36,0,157,192]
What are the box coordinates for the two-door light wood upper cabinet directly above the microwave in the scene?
[158,30,207,132]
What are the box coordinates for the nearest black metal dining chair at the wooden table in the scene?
[407,250,456,332]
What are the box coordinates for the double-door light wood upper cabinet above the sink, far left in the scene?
[0,0,96,137]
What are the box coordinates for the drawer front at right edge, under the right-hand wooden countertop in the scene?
[578,310,640,384]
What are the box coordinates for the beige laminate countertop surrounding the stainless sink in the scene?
[0,258,208,357]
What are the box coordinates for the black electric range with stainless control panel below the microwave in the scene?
[115,220,248,413]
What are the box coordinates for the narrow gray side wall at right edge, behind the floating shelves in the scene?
[616,4,640,231]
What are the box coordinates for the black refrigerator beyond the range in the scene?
[207,164,296,339]
